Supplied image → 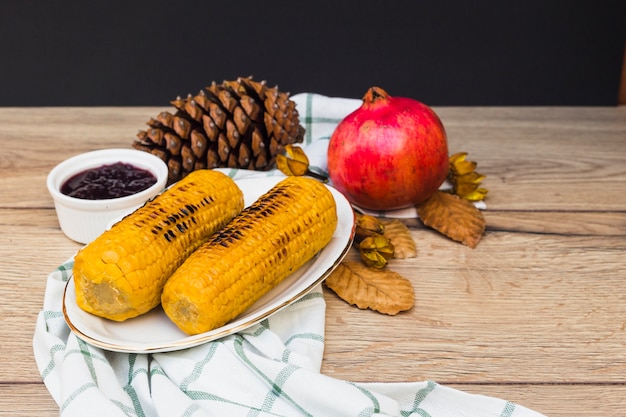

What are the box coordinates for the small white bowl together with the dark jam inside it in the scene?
[47,149,168,244]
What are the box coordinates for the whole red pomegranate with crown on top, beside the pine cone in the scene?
[328,87,448,210]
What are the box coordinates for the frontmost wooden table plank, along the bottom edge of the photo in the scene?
[0,383,626,417]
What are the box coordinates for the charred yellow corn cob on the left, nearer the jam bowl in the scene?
[73,170,244,321]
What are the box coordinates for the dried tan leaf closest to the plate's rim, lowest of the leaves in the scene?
[325,261,415,316]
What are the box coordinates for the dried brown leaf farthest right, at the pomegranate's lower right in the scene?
[416,191,486,249]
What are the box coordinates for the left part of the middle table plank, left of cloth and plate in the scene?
[0,209,81,384]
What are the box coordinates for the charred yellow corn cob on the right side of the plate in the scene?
[161,177,337,335]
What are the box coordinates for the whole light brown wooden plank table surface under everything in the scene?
[0,106,626,417]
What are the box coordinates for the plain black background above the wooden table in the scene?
[0,0,626,106]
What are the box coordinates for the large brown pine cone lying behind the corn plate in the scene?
[132,77,304,183]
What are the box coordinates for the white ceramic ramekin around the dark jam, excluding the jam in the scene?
[47,149,168,244]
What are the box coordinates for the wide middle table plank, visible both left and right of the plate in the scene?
[0,210,626,383]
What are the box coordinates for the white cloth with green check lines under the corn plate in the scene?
[33,94,541,417]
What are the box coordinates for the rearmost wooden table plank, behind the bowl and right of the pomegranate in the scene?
[0,107,626,211]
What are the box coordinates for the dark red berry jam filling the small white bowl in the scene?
[61,162,157,200]
